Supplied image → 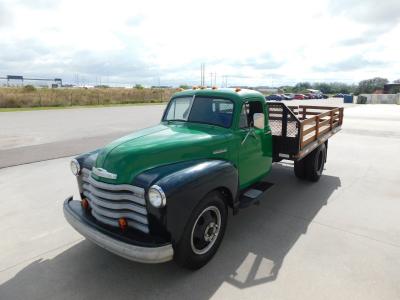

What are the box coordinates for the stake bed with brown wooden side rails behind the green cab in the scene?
[267,102,343,161]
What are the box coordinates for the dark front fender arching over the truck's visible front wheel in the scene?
[134,160,239,243]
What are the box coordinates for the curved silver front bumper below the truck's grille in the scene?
[63,197,174,263]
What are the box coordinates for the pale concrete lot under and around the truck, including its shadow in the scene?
[0,105,400,300]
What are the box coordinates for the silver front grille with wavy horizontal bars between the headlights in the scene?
[81,169,149,233]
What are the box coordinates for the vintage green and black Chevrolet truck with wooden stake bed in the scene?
[64,88,343,269]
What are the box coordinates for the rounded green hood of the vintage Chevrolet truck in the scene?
[92,123,230,184]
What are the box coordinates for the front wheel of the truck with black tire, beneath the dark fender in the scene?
[174,191,228,270]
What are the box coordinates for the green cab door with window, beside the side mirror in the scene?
[237,99,272,189]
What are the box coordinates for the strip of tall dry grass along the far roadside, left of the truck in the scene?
[0,87,175,108]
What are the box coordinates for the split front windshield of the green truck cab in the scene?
[164,97,233,128]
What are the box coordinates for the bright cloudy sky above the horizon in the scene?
[0,0,400,86]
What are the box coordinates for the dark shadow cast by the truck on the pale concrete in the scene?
[0,164,340,299]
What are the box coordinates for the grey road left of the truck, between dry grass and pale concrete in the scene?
[0,105,165,168]
